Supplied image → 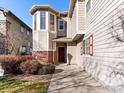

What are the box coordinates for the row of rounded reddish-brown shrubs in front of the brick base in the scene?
[0,55,55,75]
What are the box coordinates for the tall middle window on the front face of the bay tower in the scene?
[40,11,46,29]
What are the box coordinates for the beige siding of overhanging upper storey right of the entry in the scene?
[67,0,85,38]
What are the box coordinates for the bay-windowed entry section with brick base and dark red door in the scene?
[30,5,70,63]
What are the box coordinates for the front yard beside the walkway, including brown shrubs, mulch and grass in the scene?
[0,55,55,93]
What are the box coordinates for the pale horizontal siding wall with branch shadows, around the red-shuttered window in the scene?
[83,0,124,93]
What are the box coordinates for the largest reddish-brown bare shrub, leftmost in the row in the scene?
[0,55,33,74]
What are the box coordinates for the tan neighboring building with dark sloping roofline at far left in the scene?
[0,7,32,54]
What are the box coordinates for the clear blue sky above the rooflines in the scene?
[0,0,70,28]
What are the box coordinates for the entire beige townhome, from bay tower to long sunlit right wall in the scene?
[30,0,124,93]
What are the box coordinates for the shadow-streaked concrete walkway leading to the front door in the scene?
[48,64,110,93]
